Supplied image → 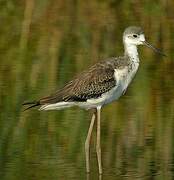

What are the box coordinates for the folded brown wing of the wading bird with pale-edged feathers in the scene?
[40,61,116,105]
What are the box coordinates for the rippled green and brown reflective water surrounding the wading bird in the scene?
[0,0,174,180]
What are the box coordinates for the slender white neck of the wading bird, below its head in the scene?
[124,43,139,63]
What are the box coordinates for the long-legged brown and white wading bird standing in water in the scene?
[23,26,165,174]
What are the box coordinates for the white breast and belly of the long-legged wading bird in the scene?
[77,63,139,109]
